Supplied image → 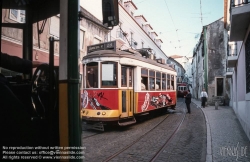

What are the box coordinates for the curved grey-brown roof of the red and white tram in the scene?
[82,50,175,71]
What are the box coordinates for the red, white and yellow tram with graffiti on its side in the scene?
[81,41,176,130]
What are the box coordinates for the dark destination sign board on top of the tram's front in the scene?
[87,41,116,53]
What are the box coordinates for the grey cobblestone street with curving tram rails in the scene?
[82,101,206,162]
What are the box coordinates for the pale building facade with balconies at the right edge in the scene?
[224,0,250,139]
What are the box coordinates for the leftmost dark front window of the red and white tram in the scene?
[86,62,98,88]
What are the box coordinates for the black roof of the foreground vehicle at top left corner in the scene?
[2,0,60,23]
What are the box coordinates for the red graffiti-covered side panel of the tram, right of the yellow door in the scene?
[137,92,176,113]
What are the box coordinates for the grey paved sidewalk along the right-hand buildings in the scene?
[192,98,250,162]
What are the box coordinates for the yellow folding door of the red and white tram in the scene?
[121,65,135,117]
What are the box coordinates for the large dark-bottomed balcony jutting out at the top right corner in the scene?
[230,0,250,41]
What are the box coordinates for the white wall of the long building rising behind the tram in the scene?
[80,0,167,60]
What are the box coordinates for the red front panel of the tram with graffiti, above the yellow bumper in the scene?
[81,89,119,110]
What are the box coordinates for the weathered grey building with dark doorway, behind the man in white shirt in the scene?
[192,19,230,105]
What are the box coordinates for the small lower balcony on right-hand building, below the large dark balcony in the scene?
[227,42,238,67]
